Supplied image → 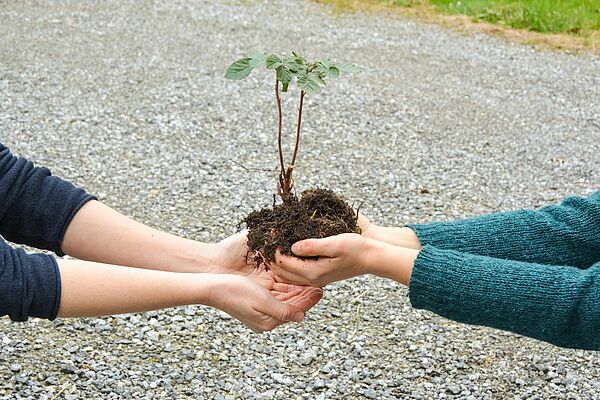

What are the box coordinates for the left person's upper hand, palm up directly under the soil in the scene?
[211,231,323,312]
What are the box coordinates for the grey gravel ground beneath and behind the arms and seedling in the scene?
[0,0,600,399]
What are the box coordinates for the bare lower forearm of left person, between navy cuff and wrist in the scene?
[58,260,216,317]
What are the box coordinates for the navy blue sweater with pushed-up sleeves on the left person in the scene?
[0,144,94,321]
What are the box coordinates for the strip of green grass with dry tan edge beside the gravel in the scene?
[316,0,600,54]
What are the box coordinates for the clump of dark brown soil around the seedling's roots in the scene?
[242,189,359,268]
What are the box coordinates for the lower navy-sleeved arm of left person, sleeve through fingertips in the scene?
[0,236,322,331]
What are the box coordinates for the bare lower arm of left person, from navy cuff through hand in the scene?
[58,260,310,332]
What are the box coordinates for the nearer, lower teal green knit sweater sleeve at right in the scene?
[409,246,600,350]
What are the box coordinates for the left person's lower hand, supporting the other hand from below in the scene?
[205,274,310,333]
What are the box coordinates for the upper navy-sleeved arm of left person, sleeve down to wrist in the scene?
[0,143,225,272]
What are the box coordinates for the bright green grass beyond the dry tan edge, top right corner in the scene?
[379,0,600,35]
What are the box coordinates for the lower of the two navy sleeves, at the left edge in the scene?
[0,239,61,321]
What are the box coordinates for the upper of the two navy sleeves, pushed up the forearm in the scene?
[0,144,94,256]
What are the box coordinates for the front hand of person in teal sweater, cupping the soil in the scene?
[270,233,372,287]
